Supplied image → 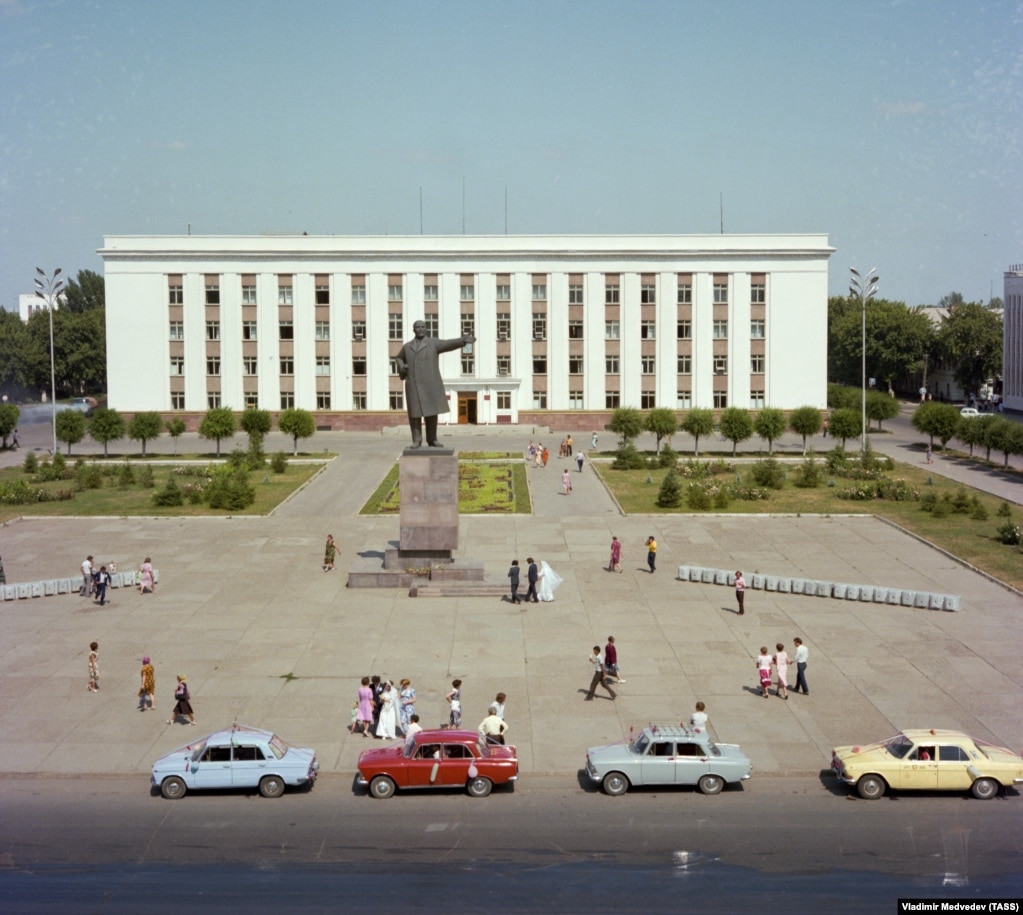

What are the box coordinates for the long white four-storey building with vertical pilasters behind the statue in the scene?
[99,234,834,429]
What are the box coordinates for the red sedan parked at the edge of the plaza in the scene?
[356,730,519,797]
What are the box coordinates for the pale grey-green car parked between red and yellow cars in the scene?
[586,725,753,796]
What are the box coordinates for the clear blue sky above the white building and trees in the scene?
[0,0,1023,308]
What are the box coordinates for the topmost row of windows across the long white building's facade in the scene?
[168,277,767,305]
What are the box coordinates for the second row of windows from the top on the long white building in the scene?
[178,313,766,342]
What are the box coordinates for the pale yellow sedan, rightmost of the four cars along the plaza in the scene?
[832,728,1023,800]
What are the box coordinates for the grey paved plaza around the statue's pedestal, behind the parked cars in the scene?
[0,419,1023,782]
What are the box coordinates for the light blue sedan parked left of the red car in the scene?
[152,725,319,800]
